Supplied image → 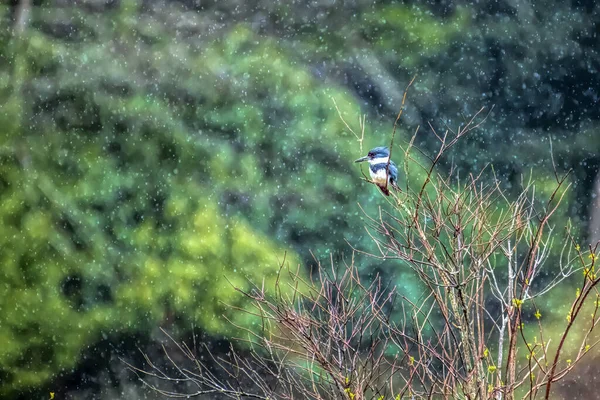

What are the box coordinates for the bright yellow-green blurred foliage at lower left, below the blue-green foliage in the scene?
[0,144,298,394]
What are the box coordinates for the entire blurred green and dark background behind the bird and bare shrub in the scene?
[0,0,600,399]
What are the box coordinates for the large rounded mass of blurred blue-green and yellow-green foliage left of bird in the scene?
[0,3,426,395]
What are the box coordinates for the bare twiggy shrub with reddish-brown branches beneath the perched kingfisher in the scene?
[129,107,600,400]
